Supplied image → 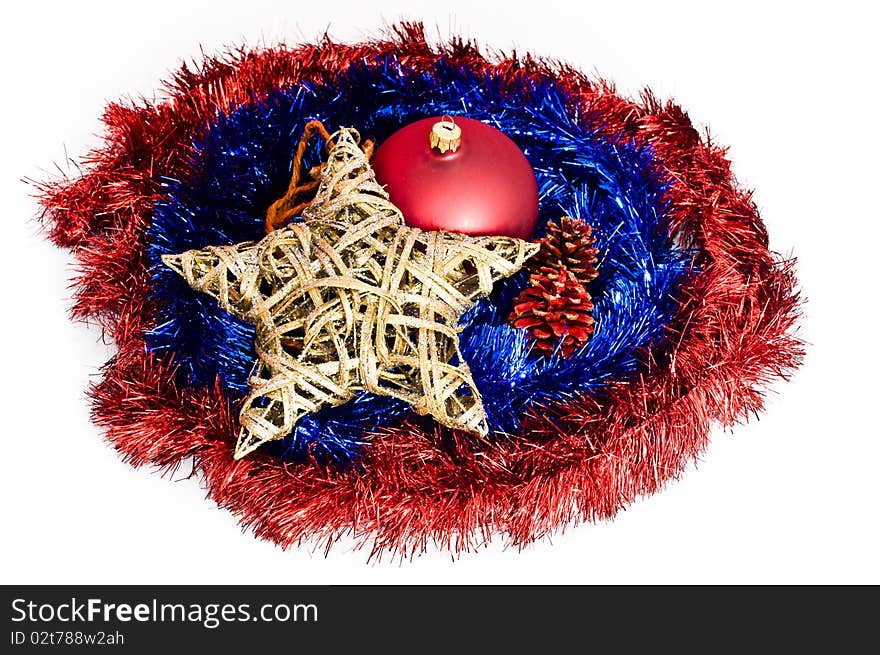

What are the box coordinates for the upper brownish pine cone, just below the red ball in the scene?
[526,216,599,285]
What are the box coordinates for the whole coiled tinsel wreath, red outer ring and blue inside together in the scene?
[41,24,801,556]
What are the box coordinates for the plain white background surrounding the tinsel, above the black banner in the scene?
[0,0,880,583]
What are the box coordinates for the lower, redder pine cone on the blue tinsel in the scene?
[508,266,593,357]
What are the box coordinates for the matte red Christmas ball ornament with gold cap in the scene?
[372,117,538,239]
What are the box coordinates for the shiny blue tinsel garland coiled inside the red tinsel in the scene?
[147,58,691,462]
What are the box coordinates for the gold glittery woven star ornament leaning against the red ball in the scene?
[162,129,538,459]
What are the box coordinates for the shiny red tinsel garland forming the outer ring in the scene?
[37,25,801,556]
